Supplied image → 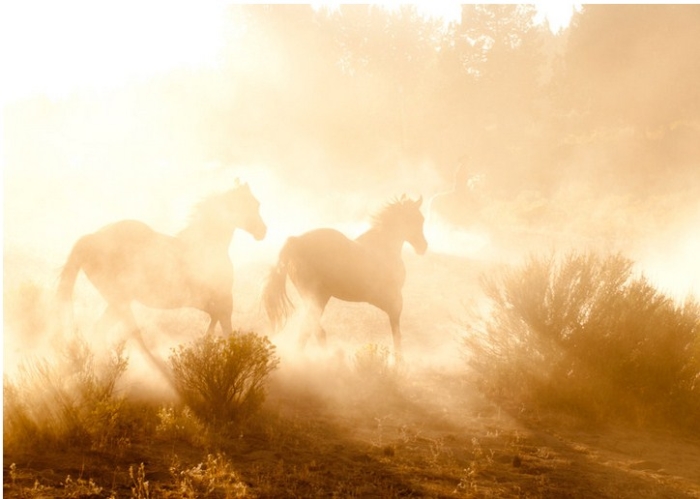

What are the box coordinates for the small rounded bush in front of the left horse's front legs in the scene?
[170,333,279,423]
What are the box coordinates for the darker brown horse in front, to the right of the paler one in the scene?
[262,194,428,358]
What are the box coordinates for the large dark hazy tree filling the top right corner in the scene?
[552,5,700,195]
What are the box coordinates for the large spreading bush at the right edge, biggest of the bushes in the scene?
[465,253,700,432]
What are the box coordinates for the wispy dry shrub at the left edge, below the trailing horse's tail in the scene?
[3,336,132,452]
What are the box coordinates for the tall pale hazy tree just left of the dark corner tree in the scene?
[439,5,547,193]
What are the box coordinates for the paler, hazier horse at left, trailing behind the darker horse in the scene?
[57,180,267,360]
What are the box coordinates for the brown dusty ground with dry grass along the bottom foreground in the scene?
[5,358,700,498]
